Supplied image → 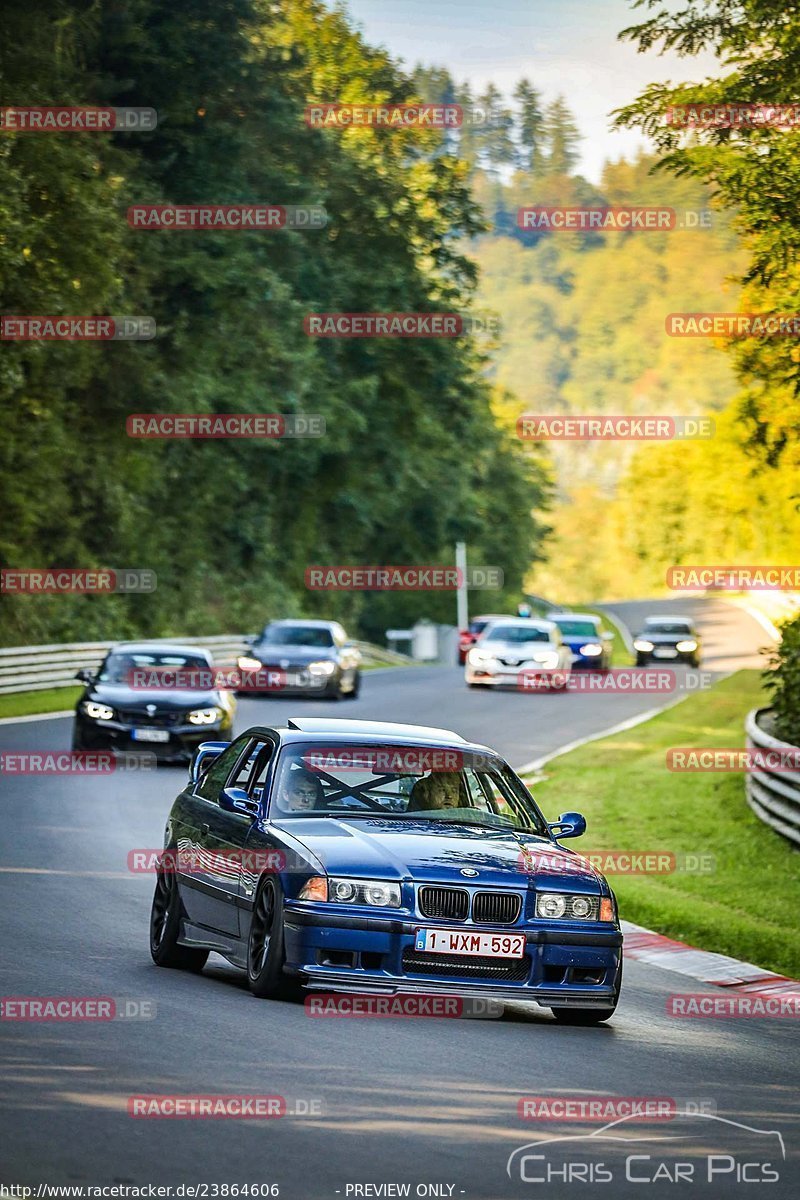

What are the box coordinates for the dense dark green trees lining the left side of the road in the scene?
[0,0,548,644]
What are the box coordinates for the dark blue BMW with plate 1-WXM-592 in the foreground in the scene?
[150,718,622,1024]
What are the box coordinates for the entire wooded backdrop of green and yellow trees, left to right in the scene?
[0,0,800,643]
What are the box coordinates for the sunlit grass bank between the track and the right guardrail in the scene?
[533,671,800,978]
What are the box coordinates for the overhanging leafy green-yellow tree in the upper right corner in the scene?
[618,0,800,468]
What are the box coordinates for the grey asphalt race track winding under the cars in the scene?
[0,601,800,1200]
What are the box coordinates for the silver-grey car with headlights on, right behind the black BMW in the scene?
[237,619,361,700]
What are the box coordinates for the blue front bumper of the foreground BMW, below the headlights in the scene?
[284,901,622,1008]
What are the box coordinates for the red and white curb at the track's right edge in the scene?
[621,920,800,996]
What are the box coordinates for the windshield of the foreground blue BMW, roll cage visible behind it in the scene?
[269,743,547,835]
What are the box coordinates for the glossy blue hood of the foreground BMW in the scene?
[273,816,600,892]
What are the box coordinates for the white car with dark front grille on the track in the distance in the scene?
[464,617,572,690]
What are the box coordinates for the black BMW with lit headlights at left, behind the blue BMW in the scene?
[72,642,236,762]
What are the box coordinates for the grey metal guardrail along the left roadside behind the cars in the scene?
[0,634,413,695]
